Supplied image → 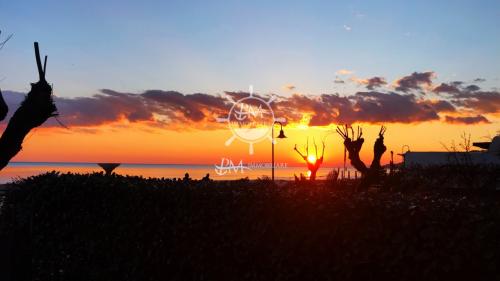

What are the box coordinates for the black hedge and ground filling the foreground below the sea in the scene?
[0,173,500,281]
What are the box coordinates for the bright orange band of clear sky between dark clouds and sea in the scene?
[13,119,500,166]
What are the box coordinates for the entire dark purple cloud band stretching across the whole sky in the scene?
[4,70,500,130]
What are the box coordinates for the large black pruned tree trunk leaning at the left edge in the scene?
[0,42,57,170]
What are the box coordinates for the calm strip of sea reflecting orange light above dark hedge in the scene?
[0,162,360,183]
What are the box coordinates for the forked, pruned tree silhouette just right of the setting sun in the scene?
[337,125,387,188]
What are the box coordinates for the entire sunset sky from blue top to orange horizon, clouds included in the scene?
[0,0,500,166]
